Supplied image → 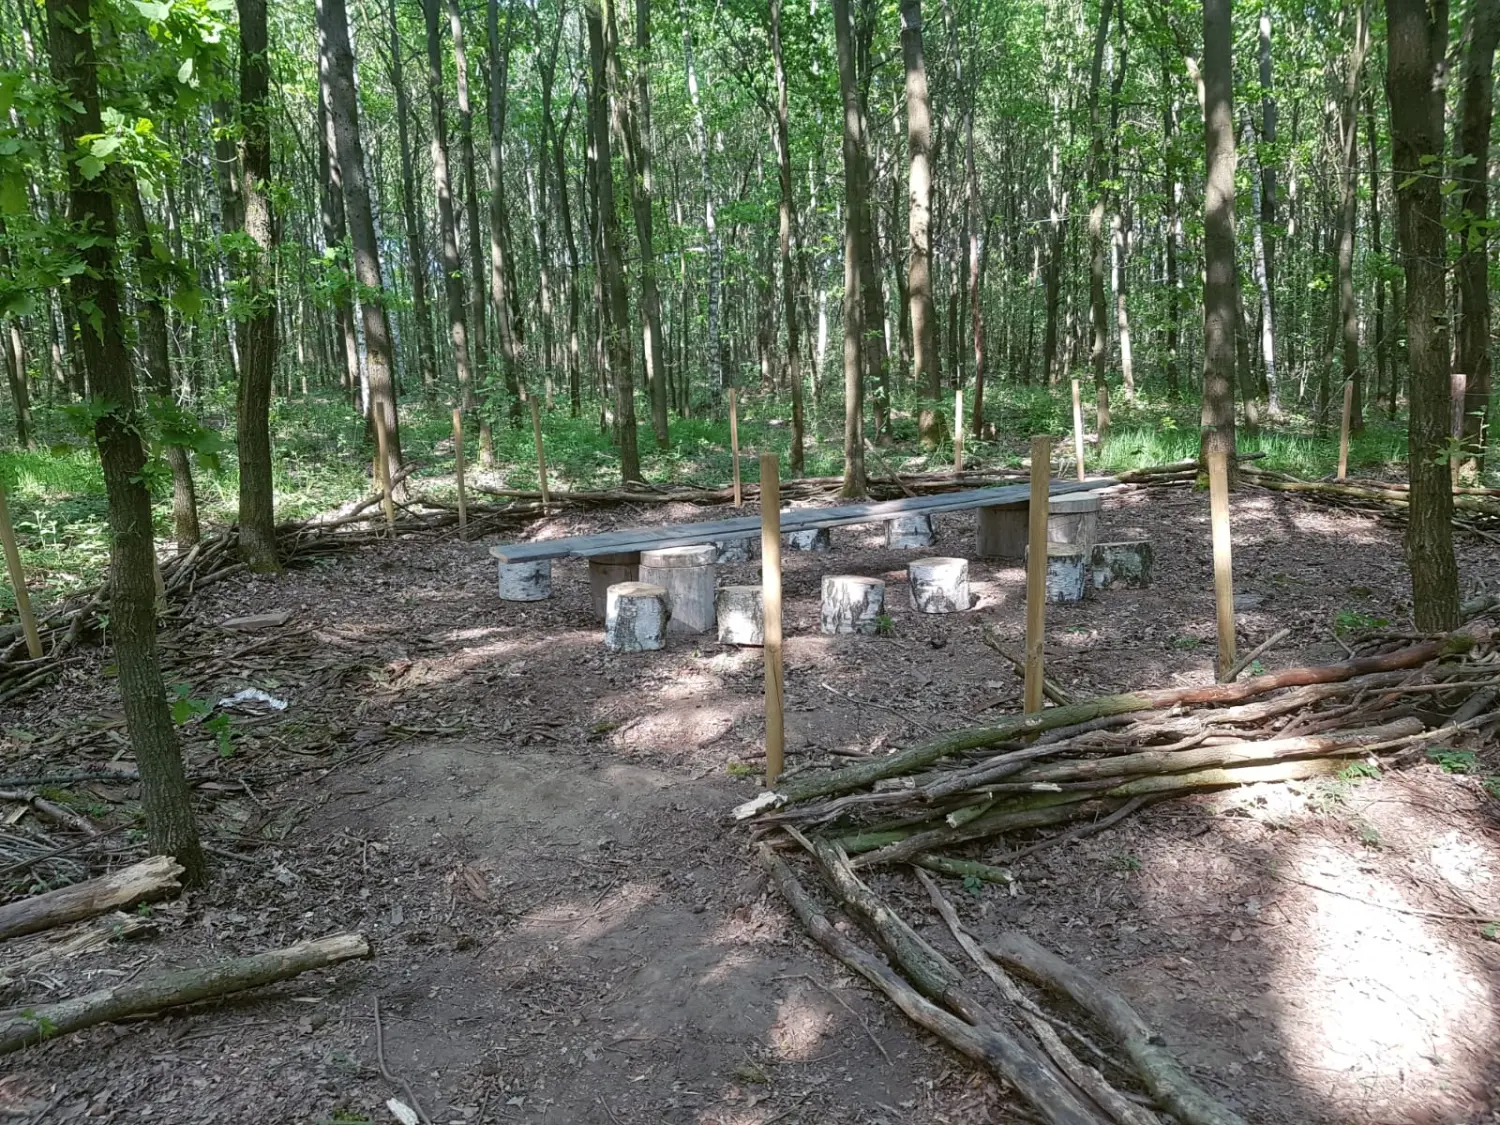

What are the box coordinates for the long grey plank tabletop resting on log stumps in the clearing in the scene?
[489,477,1116,563]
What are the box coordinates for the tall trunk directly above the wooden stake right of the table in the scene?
[1200,0,1239,479]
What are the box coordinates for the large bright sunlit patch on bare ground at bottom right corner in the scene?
[1274,845,1496,1112]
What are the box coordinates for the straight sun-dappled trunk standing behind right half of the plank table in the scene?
[902,0,944,450]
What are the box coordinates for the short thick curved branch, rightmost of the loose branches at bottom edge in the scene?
[986,932,1247,1125]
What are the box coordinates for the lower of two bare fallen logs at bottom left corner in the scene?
[0,933,371,1055]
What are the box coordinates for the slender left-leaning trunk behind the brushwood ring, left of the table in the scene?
[318,0,402,473]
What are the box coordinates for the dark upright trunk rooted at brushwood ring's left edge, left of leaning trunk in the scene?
[236,0,281,575]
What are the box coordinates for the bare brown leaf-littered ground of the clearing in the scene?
[0,488,1500,1125]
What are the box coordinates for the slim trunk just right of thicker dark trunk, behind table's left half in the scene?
[615,0,671,450]
